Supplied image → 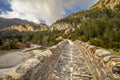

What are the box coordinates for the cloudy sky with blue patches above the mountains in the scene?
[0,0,98,25]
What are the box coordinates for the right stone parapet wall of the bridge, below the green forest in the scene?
[74,40,120,80]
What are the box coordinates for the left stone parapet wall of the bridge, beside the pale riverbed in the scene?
[0,40,69,80]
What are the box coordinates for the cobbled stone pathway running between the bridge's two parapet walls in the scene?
[50,42,92,80]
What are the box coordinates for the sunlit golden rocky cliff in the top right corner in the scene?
[91,0,120,9]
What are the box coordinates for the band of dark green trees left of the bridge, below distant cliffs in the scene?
[0,30,63,50]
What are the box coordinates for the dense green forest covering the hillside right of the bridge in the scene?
[58,5,120,49]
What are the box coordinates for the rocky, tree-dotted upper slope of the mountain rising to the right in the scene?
[50,0,120,30]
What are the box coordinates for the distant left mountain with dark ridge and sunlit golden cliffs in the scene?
[0,18,48,31]
